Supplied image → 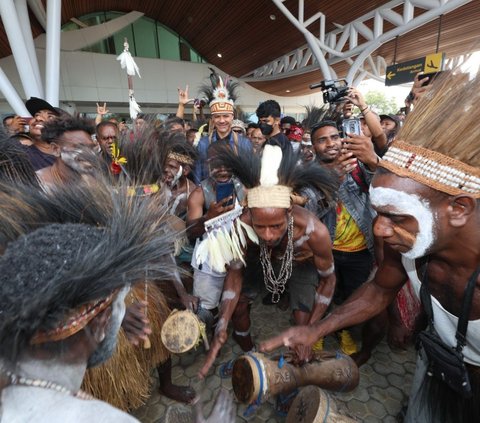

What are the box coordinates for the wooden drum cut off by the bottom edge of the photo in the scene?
[285,386,355,423]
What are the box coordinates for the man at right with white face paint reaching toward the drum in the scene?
[262,73,480,422]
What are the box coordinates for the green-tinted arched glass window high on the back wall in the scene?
[62,12,207,63]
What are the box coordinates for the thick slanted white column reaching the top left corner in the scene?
[0,0,42,98]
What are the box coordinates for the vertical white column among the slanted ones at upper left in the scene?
[45,0,62,107]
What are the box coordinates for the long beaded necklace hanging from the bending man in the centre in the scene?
[260,215,293,304]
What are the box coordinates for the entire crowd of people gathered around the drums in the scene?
[0,67,480,422]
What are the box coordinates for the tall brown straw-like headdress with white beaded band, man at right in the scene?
[380,72,480,198]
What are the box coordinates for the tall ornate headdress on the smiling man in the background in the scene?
[200,68,238,115]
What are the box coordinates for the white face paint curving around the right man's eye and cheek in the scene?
[370,186,435,260]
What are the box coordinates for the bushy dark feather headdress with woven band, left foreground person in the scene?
[0,179,178,362]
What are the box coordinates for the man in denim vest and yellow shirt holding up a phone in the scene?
[306,121,378,355]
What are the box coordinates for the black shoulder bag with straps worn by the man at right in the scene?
[417,268,480,398]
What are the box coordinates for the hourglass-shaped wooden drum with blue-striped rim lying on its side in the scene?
[232,352,359,404]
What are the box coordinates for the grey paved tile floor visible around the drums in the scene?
[133,299,415,423]
